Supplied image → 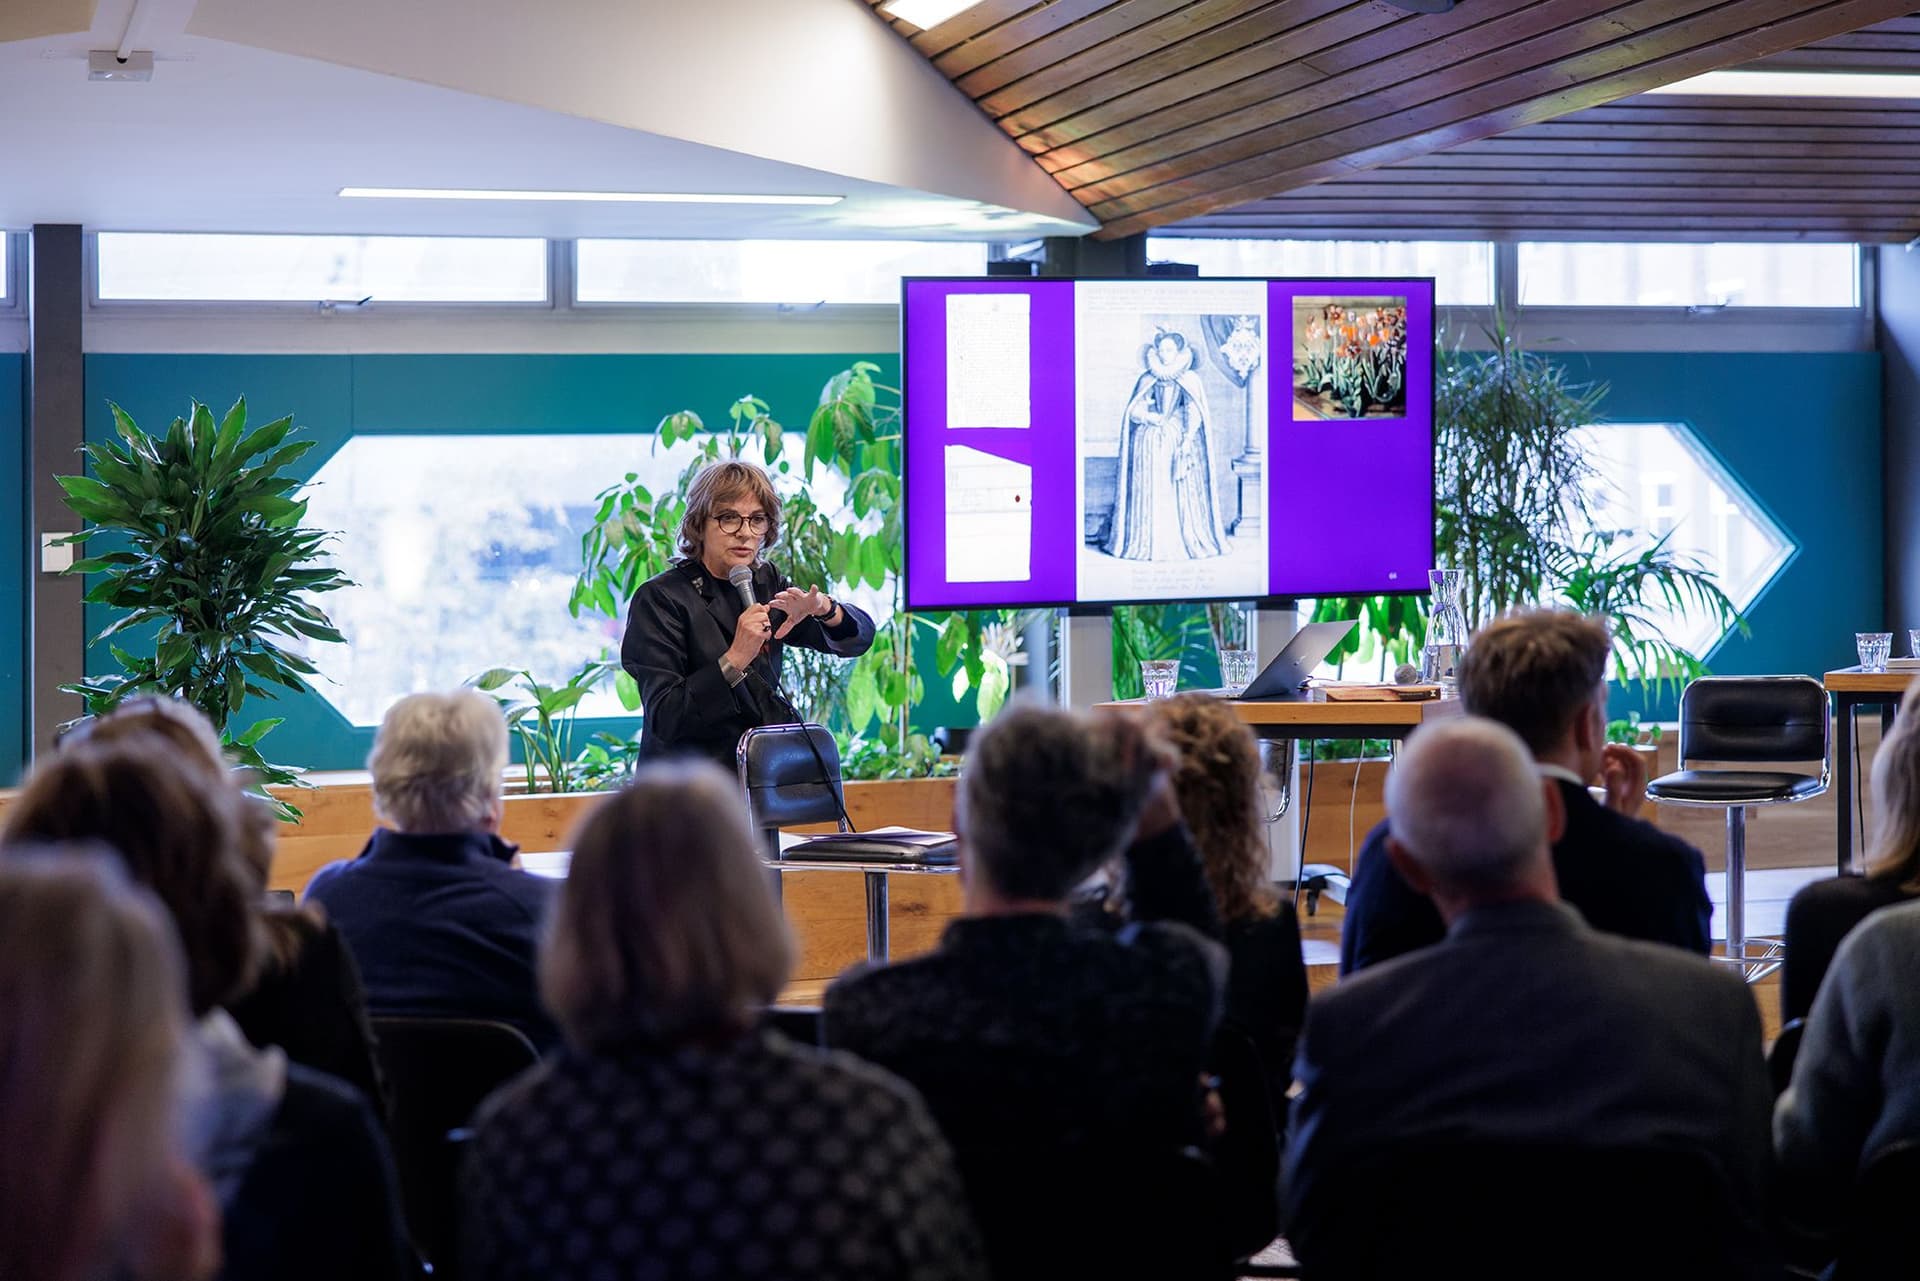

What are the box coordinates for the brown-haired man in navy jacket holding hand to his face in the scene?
[1340,609,1713,974]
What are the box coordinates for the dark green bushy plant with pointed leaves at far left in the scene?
[60,398,351,816]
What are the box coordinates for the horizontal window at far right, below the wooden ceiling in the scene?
[1521,242,1860,307]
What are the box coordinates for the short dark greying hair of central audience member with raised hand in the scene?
[954,703,1165,903]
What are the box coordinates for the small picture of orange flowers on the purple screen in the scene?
[1294,298,1407,423]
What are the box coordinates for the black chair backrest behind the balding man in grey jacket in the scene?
[1288,1141,1770,1281]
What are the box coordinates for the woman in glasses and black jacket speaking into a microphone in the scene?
[620,459,874,772]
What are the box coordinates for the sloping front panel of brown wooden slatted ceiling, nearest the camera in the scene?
[868,0,1912,238]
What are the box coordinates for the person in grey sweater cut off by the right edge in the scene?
[1774,898,1920,1244]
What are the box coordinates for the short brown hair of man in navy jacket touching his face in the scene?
[1459,609,1613,757]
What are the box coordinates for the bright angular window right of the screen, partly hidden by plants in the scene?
[1580,423,1799,659]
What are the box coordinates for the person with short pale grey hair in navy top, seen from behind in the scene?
[307,689,559,1047]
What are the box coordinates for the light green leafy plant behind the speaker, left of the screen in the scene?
[568,361,1012,776]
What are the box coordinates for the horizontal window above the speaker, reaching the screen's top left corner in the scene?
[574,240,987,305]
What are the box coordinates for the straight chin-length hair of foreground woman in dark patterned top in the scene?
[540,761,795,1052]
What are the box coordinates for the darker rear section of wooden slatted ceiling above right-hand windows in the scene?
[1165,17,1920,242]
